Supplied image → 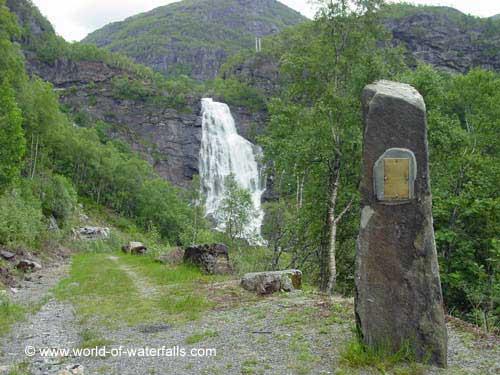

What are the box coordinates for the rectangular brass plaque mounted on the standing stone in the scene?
[384,158,410,200]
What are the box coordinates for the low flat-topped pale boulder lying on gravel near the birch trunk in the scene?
[241,269,302,295]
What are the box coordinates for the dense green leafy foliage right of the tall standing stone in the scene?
[401,66,500,330]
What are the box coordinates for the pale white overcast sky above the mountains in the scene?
[32,0,500,41]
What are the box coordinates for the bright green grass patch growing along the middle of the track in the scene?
[55,253,217,328]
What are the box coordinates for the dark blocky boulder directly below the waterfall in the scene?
[184,244,232,274]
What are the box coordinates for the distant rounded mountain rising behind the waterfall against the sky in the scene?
[84,0,306,80]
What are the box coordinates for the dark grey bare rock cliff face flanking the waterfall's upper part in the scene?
[27,58,265,187]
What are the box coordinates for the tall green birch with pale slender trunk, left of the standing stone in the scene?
[261,0,402,293]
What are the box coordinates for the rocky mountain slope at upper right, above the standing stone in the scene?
[384,4,500,73]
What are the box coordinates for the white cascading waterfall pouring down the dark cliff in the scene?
[200,98,265,242]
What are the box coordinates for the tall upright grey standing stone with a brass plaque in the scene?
[355,81,447,367]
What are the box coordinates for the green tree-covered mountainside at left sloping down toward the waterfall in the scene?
[0,0,214,254]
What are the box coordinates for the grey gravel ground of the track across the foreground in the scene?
[0,255,500,375]
